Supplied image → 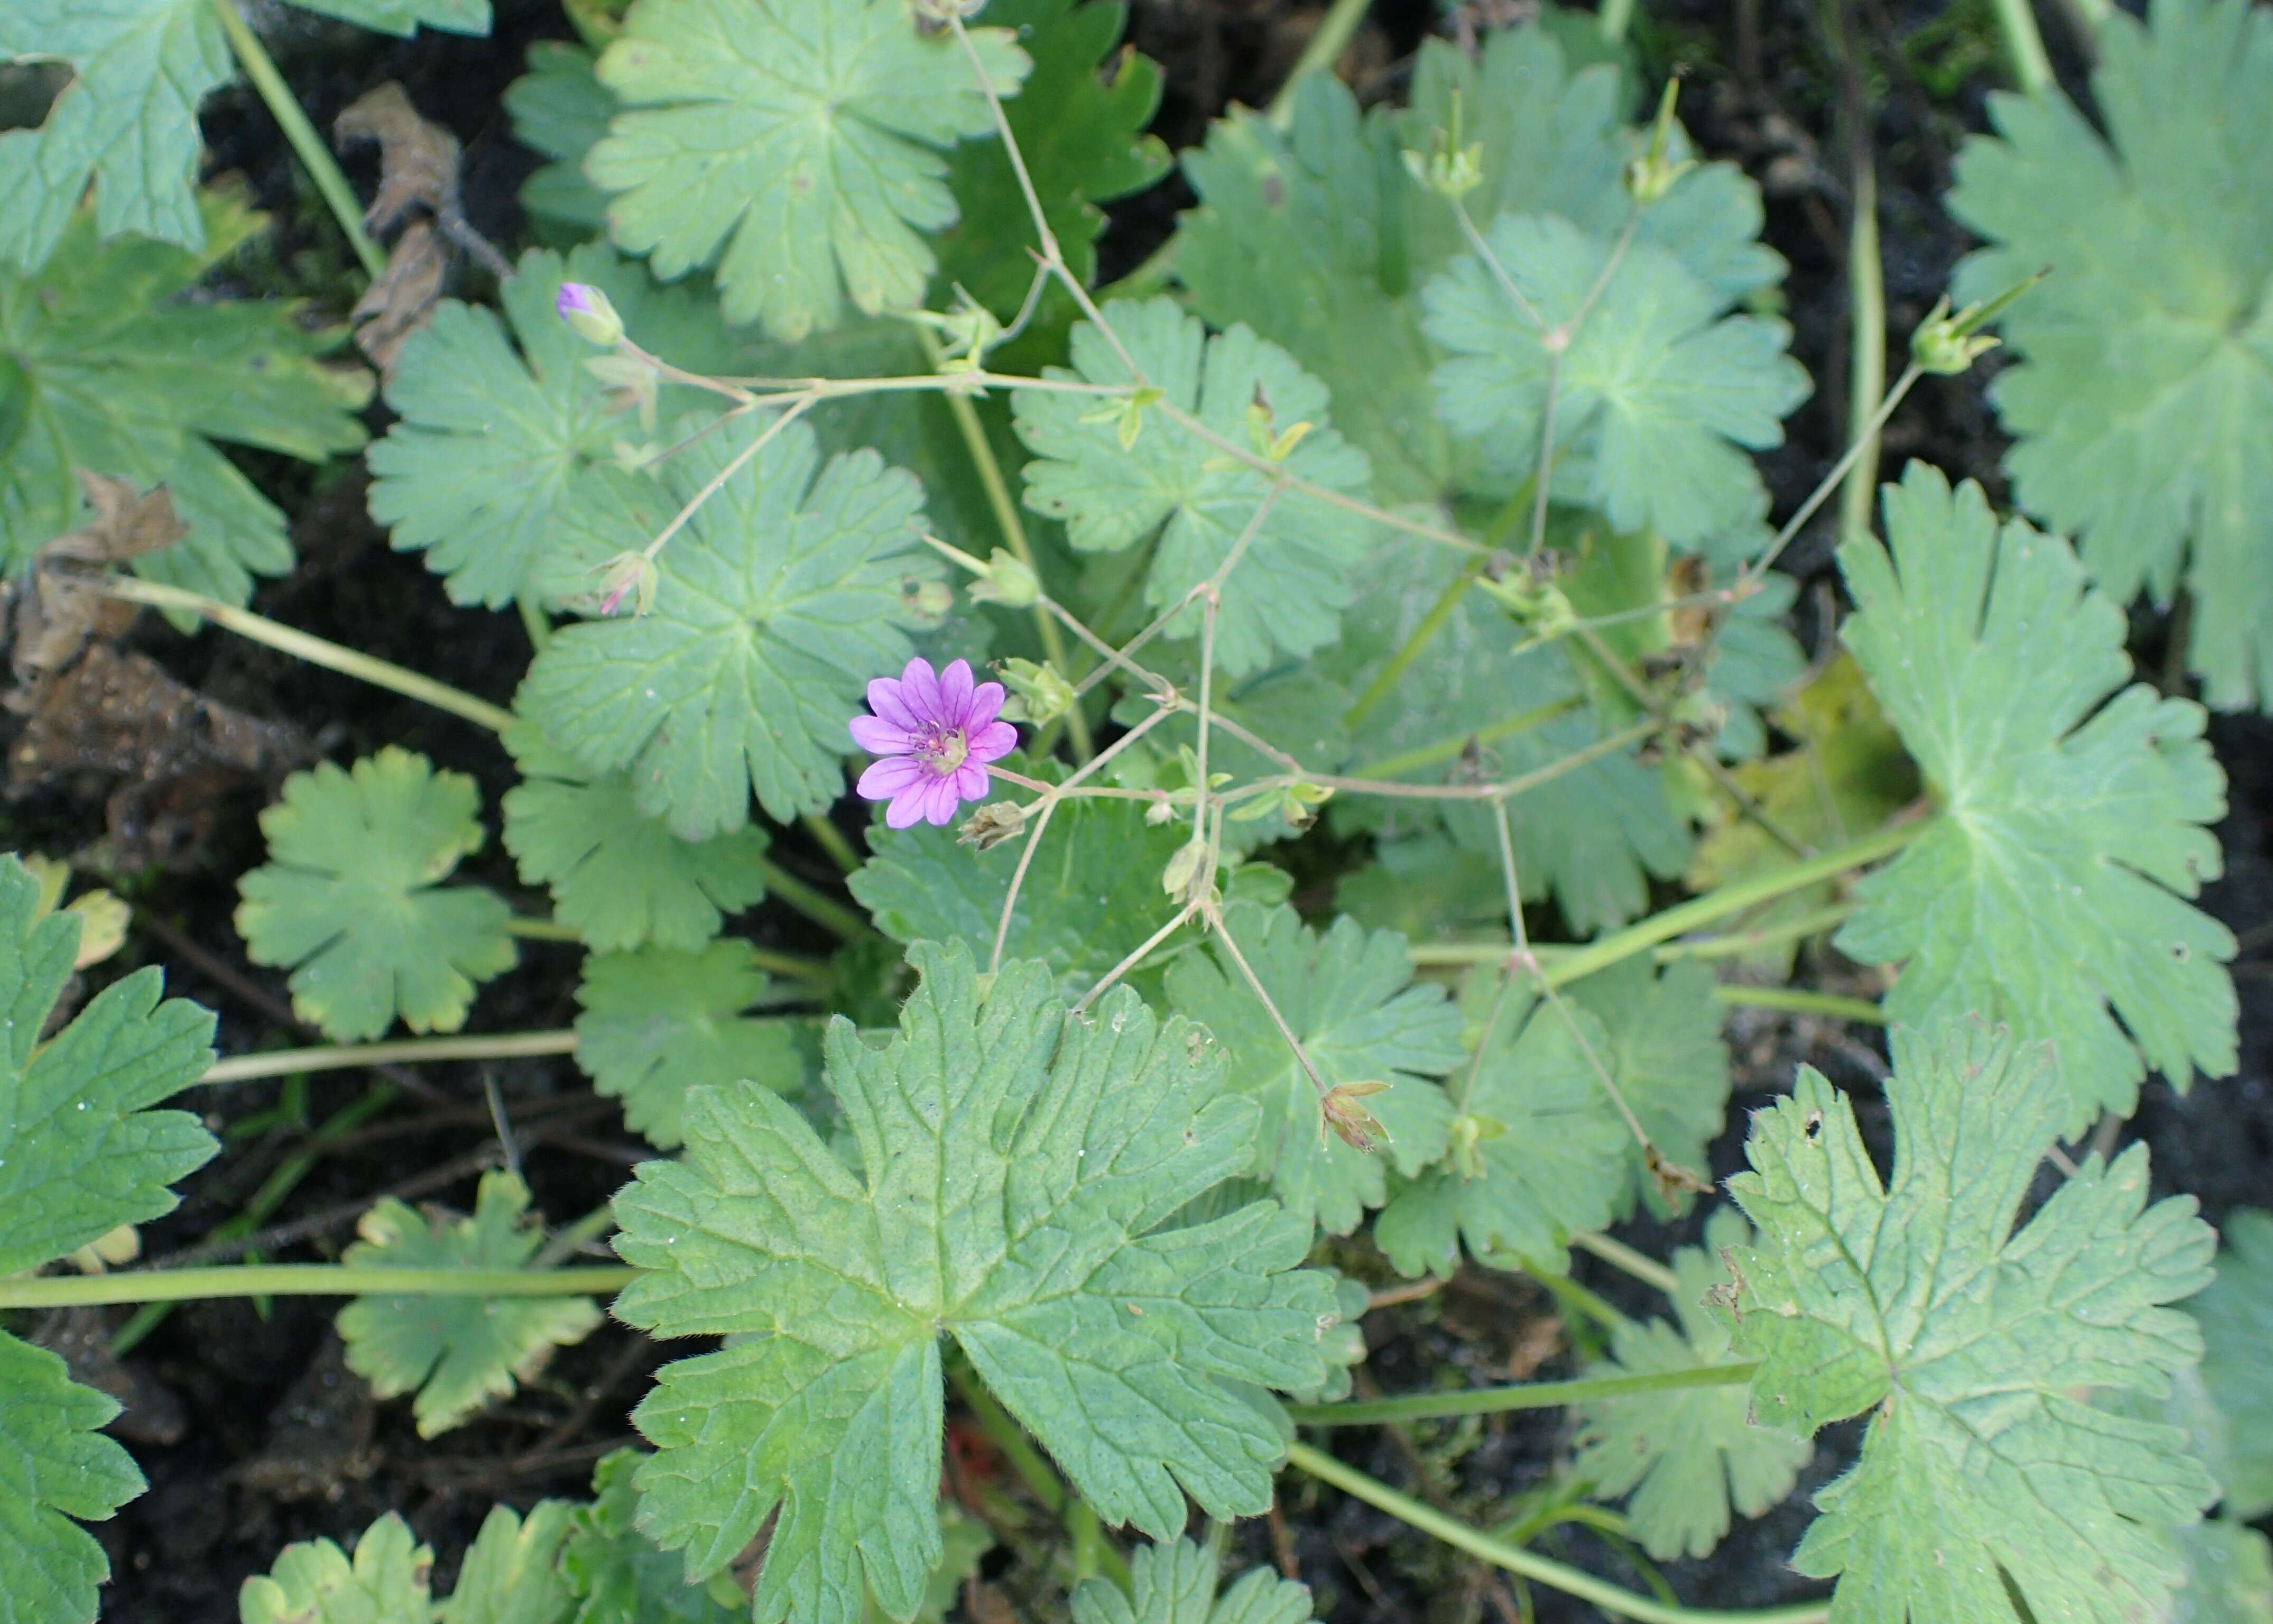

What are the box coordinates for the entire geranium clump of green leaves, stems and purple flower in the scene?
[0,0,2273,1624]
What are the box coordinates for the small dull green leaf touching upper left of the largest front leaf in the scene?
[575,939,805,1151]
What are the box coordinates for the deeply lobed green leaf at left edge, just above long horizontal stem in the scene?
[0,855,218,1276]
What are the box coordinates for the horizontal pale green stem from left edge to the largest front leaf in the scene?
[0,1262,643,1308]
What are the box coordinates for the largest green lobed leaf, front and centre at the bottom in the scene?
[616,944,1339,1624]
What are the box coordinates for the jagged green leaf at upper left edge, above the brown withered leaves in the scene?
[0,191,371,603]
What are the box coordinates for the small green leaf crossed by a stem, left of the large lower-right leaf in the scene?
[1570,1208,1814,1563]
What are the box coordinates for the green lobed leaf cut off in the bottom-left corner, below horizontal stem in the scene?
[0,1337,143,1624]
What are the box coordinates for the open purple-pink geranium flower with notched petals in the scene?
[850,660,1018,828]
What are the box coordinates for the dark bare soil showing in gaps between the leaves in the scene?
[12,0,2273,1624]
